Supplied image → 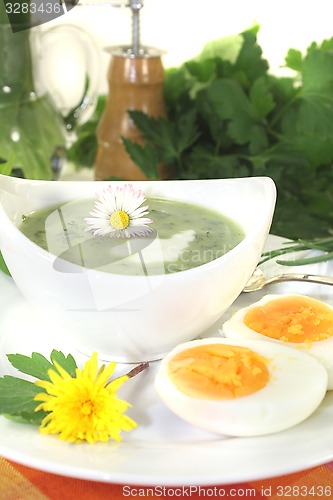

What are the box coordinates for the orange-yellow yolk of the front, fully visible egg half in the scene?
[168,344,269,400]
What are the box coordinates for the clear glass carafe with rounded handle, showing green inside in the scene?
[0,24,99,179]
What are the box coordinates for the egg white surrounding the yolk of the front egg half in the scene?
[155,337,327,436]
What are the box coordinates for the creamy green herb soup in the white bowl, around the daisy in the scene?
[20,198,244,275]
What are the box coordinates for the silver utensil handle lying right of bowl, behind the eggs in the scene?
[243,268,333,292]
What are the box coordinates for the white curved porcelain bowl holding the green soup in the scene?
[0,175,276,363]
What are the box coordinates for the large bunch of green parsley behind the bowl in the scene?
[120,26,333,240]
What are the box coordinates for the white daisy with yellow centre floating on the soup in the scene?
[84,184,153,238]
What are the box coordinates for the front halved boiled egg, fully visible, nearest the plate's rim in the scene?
[155,337,327,436]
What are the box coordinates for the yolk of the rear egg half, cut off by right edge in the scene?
[244,296,333,343]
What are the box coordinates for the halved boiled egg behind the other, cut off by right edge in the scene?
[222,294,333,390]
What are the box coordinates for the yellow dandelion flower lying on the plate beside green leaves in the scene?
[34,353,136,443]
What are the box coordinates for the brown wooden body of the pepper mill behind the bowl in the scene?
[95,47,167,180]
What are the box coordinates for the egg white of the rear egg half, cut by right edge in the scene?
[222,293,333,390]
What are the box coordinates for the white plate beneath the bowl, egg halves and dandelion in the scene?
[0,237,333,486]
